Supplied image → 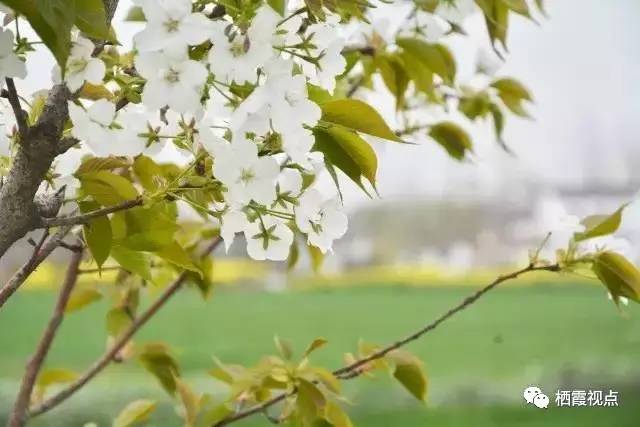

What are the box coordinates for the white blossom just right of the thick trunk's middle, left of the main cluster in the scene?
[69,99,116,157]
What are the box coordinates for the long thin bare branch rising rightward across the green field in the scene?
[212,264,560,427]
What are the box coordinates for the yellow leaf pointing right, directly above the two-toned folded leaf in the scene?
[320,99,401,142]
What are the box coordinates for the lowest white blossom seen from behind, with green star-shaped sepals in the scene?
[244,216,293,261]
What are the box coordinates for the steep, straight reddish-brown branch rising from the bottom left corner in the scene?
[7,250,82,427]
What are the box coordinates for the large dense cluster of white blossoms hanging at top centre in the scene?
[64,0,347,260]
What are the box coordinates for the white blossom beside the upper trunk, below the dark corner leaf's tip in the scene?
[53,36,106,92]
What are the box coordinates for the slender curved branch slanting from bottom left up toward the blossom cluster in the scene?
[29,237,222,417]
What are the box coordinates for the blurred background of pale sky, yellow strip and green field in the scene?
[0,0,640,427]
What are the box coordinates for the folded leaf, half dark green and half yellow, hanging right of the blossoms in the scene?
[314,126,378,192]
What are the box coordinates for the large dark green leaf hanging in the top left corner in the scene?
[2,0,75,69]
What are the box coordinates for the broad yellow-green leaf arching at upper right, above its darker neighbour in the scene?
[397,37,457,84]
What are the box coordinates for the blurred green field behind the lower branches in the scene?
[0,284,640,427]
